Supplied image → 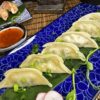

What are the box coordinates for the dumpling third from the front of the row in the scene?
[42,42,85,61]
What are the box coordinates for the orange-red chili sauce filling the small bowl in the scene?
[0,27,24,48]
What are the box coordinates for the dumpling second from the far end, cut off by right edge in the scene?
[69,20,100,37]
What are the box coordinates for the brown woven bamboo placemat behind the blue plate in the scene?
[24,0,79,35]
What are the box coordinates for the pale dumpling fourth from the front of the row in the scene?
[56,31,98,48]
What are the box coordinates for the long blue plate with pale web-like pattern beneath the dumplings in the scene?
[0,3,100,100]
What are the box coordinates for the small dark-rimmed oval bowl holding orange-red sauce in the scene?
[0,24,27,53]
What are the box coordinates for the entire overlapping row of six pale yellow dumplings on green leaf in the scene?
[0,13,100,88]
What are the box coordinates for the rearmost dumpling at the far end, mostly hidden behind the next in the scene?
[78,12,100,21]
